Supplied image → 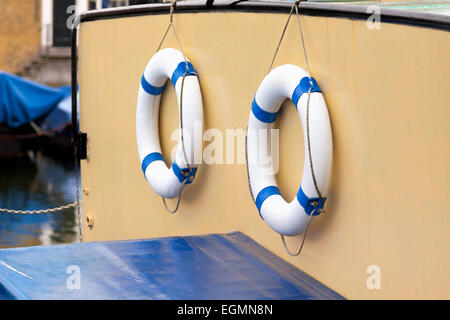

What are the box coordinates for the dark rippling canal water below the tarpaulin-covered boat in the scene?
[0,153,78,248]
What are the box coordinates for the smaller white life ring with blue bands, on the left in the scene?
[136,48,203,199]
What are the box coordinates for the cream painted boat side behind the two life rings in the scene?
[79,12,450,299]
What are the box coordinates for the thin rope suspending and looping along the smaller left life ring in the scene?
[156,0,191,214]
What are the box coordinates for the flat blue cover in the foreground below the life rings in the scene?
[0,232,343,300]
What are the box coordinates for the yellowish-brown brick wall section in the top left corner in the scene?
[0,0,41,73]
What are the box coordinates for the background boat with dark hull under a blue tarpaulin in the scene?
[0,71,73,159]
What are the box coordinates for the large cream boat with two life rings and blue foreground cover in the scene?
[0,1,450,299]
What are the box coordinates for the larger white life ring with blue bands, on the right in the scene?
[247,64,333,236]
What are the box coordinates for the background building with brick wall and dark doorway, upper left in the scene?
[0,0,129,86]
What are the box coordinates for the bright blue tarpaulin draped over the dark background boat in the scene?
[0,71,71,128]
